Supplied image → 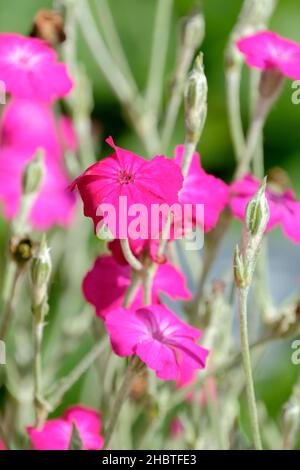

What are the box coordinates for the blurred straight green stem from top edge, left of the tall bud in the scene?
[146,0,173,116]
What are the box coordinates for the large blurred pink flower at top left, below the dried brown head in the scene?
[0,33,72,102]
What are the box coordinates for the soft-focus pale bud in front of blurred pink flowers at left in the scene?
[22,149,44,195]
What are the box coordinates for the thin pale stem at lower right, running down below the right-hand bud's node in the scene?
[238,288,262,450]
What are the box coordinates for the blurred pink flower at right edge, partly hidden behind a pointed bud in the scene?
[230,175,300,243]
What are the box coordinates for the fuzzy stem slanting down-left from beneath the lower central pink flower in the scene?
[103,356,139,449]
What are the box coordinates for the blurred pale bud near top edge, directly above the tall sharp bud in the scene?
[181,11,205,49]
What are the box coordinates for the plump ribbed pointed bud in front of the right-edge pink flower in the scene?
[245,178,270,236]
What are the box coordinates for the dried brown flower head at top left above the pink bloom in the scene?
[30,10,66,47]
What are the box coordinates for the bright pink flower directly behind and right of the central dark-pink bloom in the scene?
[175,145,229,232]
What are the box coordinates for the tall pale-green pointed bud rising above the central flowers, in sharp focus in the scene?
[185,53,207,144]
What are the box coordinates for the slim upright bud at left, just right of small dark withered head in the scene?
[31,237,52,307]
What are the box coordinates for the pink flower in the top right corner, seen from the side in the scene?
[237,31,300,80]
